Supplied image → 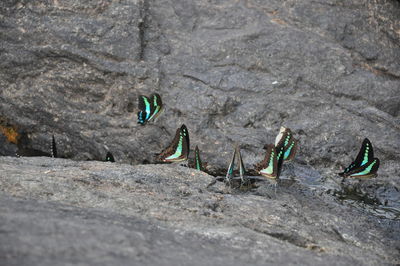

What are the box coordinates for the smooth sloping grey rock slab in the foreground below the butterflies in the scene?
[0,157,400,265]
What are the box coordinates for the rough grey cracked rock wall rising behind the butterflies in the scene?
[0,0,400,176]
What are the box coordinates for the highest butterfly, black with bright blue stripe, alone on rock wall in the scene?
[138,93,163,125]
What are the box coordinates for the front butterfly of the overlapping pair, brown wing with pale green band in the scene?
[254,144,285,179]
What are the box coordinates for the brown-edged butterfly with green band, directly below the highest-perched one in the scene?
[158,124,190,162]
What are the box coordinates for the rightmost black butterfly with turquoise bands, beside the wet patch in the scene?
[339,138,379,178]
